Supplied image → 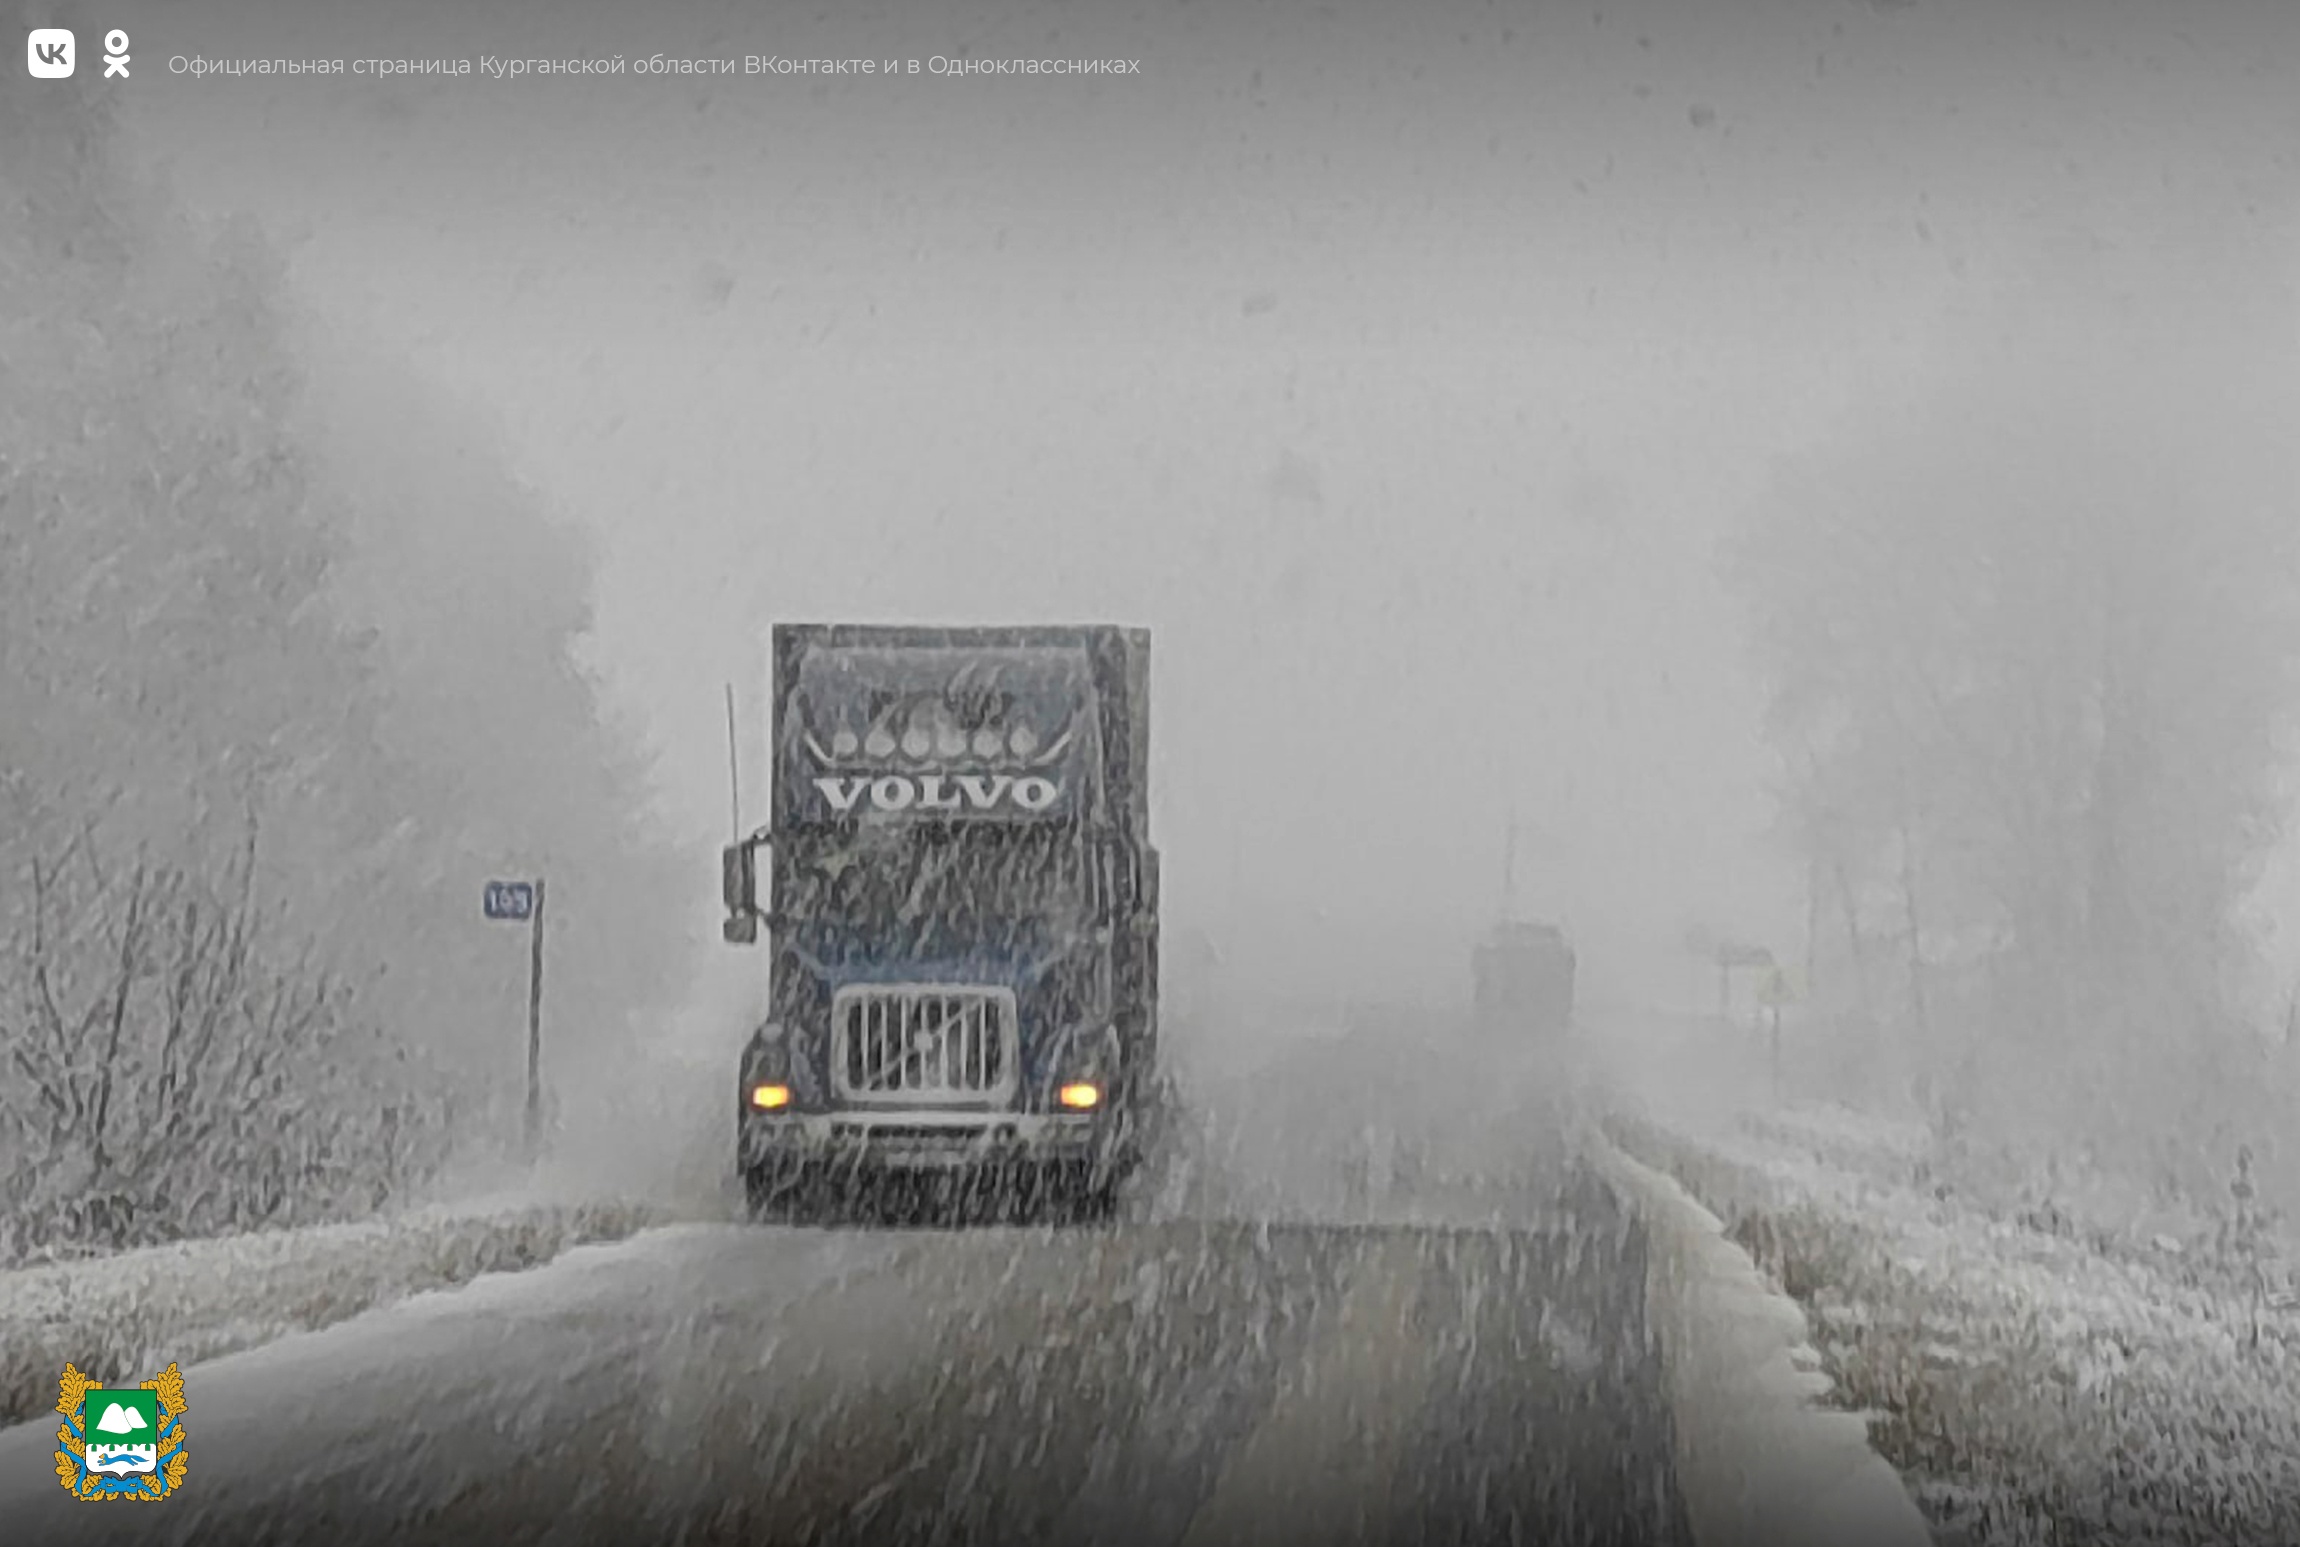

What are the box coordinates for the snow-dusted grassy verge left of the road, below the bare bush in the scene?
[0,1202,669,1425]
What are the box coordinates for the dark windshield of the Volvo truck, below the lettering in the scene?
[775,823,1093,949]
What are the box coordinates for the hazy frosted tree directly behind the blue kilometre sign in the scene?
[285,349,690,1090]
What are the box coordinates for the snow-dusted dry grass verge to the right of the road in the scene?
[1622,1113,2300,1547]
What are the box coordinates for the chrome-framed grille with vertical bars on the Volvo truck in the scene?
[830,984,1017,1106]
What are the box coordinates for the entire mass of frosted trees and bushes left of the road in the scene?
[0,76,685,1257]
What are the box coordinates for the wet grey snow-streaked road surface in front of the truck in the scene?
[0,1011,1932,1547]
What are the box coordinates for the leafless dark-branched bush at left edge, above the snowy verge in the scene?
[0,839,453,1253]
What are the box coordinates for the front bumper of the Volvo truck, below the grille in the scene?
[738,1110,1113,1172]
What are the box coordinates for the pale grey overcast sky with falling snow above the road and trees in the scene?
[54,0,2300,1002]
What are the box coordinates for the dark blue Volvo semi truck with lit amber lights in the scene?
[722,623,1159,1216]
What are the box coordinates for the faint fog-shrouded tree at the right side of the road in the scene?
[1732,204,2300,1172]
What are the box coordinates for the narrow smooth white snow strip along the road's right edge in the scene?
[1599,1145,1932,1547]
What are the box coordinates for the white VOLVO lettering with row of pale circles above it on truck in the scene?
[803,694,1079,816]
